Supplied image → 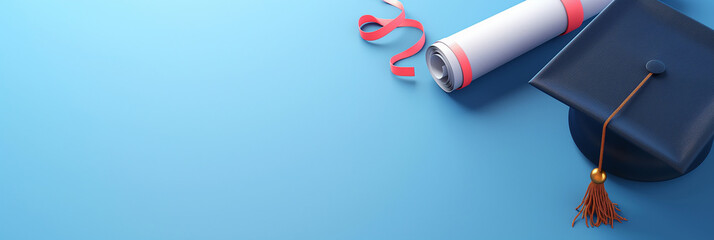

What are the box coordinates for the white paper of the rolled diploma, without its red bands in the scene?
[426,0,612,92]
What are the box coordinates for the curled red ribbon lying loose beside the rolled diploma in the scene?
[357,0,426,76]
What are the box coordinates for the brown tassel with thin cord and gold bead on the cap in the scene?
[572,73,652,228]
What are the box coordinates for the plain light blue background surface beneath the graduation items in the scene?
[0,0,714,239]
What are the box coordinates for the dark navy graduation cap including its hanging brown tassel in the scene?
[530,0,714,226]
